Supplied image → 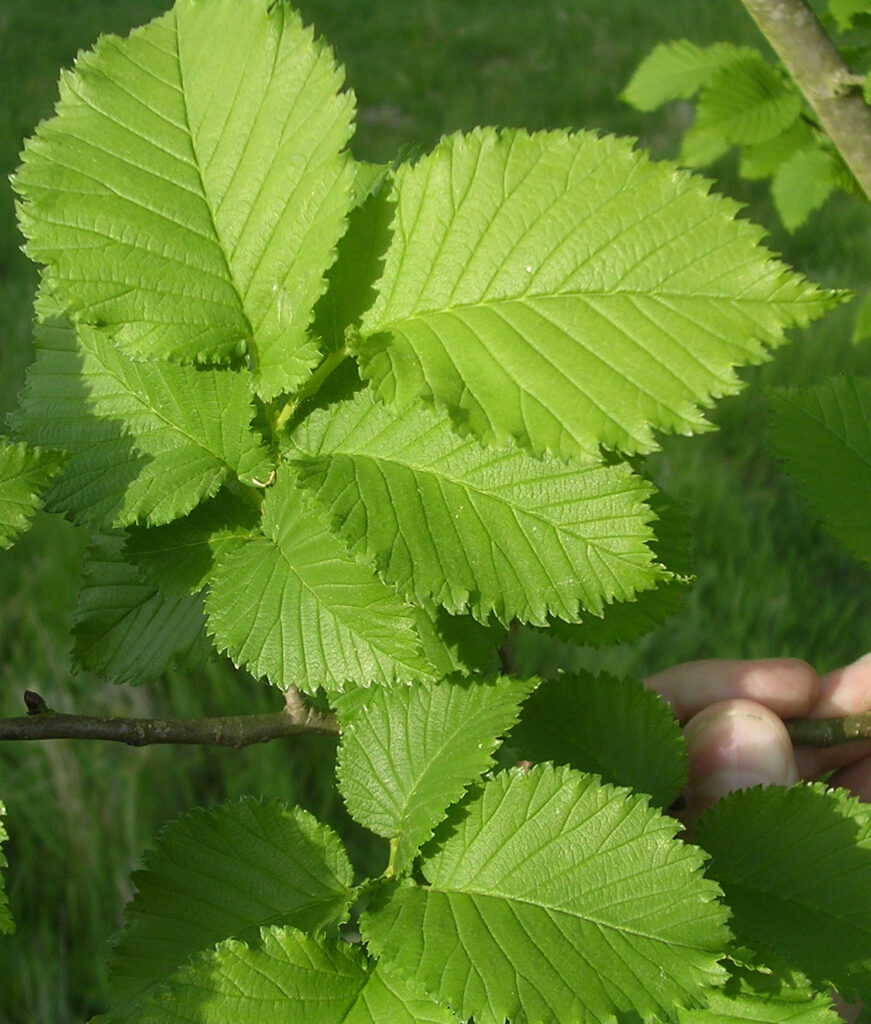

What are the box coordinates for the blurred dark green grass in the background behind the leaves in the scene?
[0,0,871,1024]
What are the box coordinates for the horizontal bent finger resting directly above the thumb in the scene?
[644,657,820,722]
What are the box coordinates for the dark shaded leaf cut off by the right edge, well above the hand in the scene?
[770,377,871,562]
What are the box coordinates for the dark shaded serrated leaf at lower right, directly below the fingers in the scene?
[696,783,871,1000]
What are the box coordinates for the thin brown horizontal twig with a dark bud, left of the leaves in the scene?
[0,687,339,748]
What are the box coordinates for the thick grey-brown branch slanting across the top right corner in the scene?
[742,0,871,199]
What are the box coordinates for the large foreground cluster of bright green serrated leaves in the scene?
[0,0,871,1024]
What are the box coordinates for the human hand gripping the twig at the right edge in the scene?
[644,654,871,830]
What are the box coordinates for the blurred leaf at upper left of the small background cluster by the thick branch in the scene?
[620,39,755,111]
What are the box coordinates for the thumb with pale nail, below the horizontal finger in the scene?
[682,699,799,824]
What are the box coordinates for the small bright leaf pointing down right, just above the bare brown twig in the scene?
[206,467,432,692]
